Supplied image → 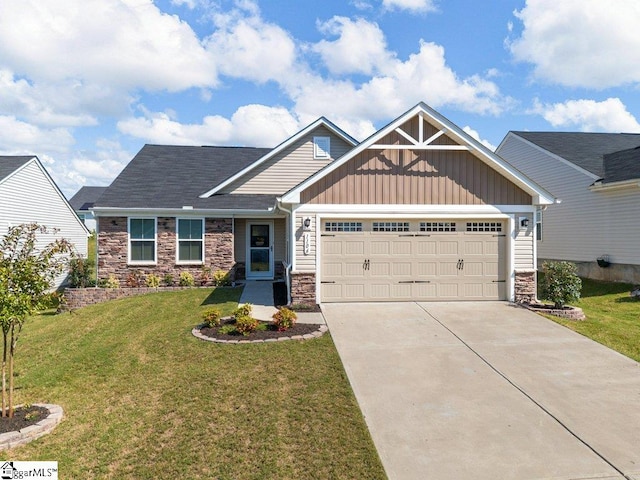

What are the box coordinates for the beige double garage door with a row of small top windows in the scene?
[320,220,506,302]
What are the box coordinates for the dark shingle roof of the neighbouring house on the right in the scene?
[510,131,640,178]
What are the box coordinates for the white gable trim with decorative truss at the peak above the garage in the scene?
[281,102,556,205]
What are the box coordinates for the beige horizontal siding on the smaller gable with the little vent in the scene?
[224,127,352,195]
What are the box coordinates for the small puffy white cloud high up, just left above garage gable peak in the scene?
[312,16,394,75]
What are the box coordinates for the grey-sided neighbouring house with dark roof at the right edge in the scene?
[496,132,640,283]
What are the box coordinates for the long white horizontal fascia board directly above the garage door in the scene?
[296,204,536,218]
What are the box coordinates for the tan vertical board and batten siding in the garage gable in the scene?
[301,149,531,205]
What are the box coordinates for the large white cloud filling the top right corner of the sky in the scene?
[509,0,640,88]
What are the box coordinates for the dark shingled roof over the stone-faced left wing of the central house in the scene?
[94,145,275,210]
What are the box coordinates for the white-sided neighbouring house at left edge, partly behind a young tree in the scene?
[0,156,89,287]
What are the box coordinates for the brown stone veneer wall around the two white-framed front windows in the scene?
[98,217,234,286]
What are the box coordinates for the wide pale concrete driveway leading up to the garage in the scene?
[322,302,640,480]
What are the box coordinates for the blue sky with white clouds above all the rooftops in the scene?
[0,0,640,196]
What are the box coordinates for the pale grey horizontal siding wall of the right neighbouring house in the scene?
[496,136,640,265]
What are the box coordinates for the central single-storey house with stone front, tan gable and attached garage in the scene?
[93,103,554,303]
